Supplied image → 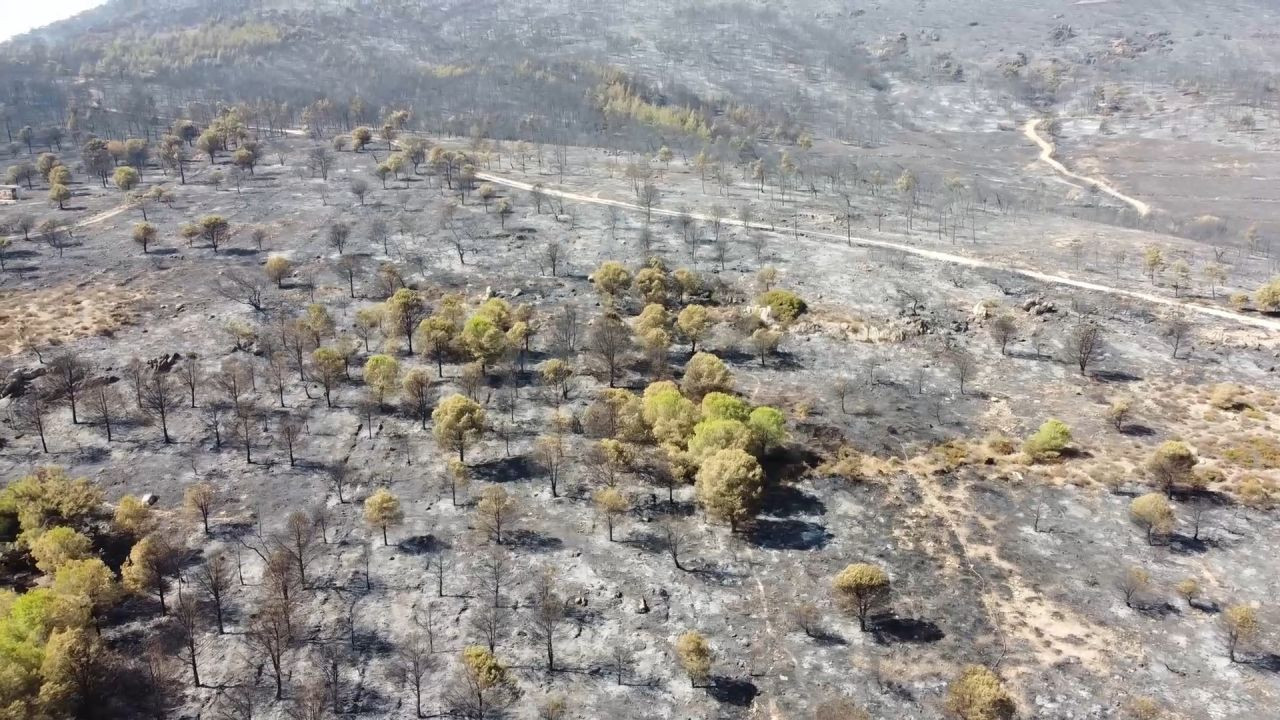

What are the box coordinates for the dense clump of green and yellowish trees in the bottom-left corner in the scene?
[0,466,174,719]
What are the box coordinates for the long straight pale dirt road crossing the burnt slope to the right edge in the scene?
[476,173,1280,331]
